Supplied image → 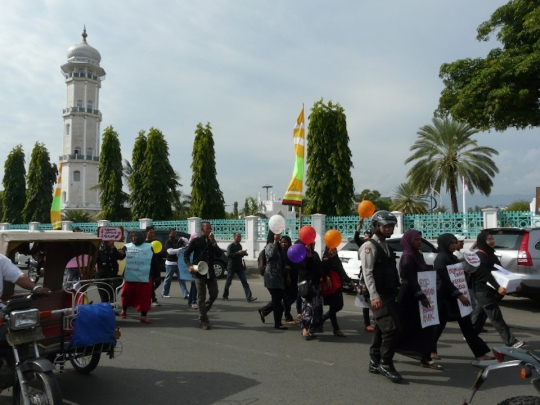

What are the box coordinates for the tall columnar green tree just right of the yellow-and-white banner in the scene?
[306,99,354,215]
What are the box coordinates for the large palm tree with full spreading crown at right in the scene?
[405,117,499,212]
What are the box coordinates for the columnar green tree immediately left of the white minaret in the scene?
[22,142,58,223]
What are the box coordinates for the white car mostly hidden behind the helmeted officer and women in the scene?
[338,235,438,290]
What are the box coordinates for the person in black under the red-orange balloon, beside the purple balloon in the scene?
[297,241,330,340]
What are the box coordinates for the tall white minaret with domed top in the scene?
[60,27,105,215]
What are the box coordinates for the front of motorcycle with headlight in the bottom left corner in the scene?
[0,292,62,405]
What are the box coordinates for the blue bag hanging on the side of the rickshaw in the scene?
[68,302,116,347]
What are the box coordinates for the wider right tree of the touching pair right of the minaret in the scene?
[138,128,180,220]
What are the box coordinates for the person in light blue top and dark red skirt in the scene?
[120,231,161,323]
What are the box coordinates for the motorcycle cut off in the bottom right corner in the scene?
[463,346,540,405]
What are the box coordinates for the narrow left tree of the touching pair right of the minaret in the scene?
[129,130,147,221]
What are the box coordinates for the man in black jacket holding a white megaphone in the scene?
[184,221,221,330]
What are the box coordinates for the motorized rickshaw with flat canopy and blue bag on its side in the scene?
[0,230,122,403]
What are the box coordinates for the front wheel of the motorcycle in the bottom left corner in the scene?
[13,370,62,405]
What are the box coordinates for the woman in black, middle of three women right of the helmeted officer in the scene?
[431,233,492,360]
